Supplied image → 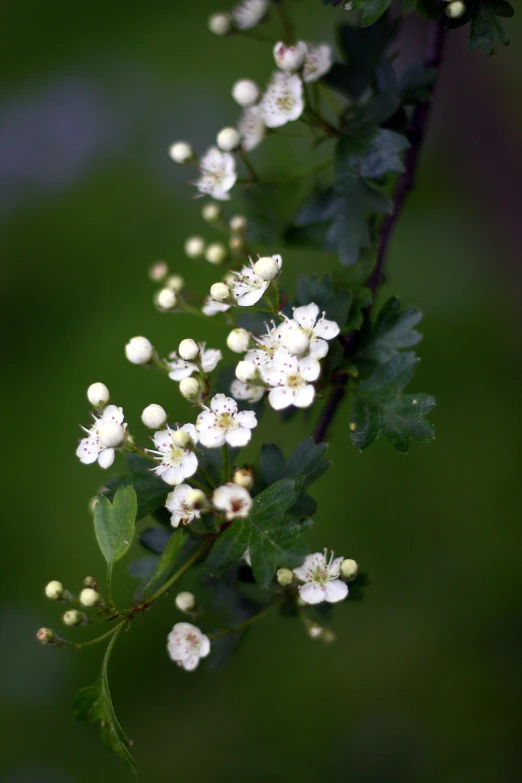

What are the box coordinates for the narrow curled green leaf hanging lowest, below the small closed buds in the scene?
[73,631,138,779]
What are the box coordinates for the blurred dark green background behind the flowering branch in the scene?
[0,0,522,783]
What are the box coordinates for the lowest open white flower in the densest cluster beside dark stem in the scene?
[259,348,321,411]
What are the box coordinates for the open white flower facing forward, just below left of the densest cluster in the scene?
[196,394,257,448]
